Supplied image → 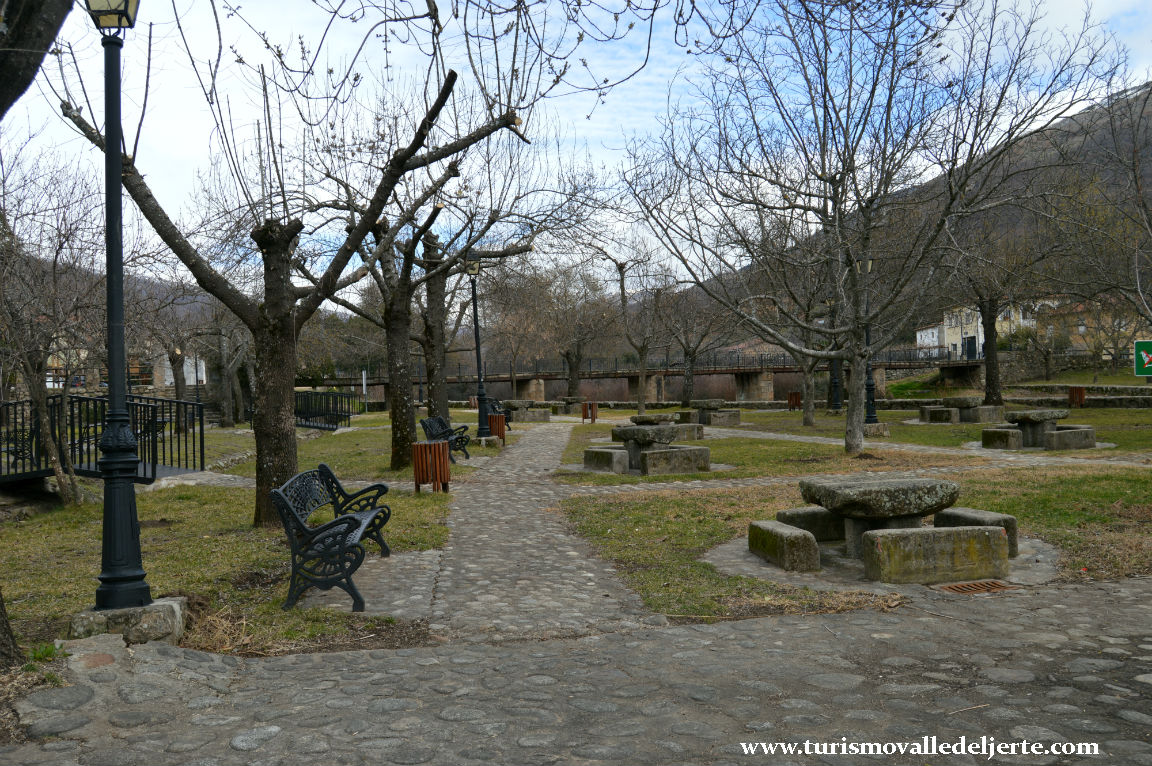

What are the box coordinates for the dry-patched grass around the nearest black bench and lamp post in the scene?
[0,486,448,654]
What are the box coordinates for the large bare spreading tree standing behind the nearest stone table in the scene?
[626,0,1106,454]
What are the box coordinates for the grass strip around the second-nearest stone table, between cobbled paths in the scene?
[556,416,987,485]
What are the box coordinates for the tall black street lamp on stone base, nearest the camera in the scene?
[85,0,152,609]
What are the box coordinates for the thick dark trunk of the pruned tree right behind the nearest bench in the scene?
[252,313,296,526]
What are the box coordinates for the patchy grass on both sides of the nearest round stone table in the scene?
[561,467,1152,616]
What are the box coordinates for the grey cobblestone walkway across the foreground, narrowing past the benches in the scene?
[0,423,1152,766]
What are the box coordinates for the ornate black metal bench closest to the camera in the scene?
[272,463,392,612]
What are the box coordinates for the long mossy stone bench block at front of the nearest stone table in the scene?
[863,526,1008,585]
